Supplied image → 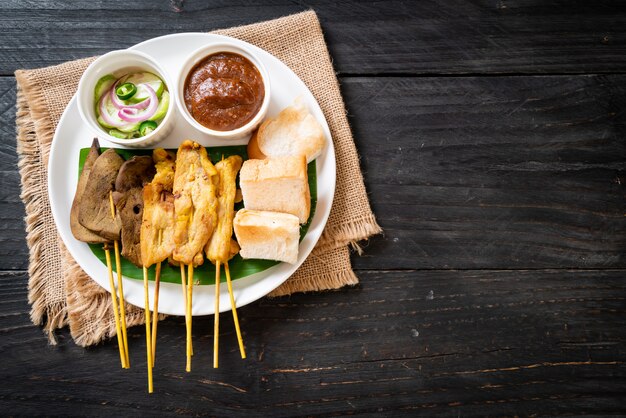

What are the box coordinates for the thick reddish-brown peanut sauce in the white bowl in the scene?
[184,52,265,131]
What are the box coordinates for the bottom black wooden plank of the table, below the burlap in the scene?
[0,270,626,416]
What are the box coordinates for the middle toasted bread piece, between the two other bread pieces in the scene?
[239,155,311,223]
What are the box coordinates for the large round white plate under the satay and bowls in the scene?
[48,33,336,315]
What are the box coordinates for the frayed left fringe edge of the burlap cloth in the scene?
[16,72,67,345]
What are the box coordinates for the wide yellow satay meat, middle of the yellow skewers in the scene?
[173,140,217,266]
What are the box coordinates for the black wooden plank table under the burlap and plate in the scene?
[0,0,626,416]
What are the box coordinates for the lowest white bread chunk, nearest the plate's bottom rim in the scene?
[233,209,300,264]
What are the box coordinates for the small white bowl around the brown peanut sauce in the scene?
[176,40,270,140]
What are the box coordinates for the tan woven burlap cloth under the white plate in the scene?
[15,11,381,346]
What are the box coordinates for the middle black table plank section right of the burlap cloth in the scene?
[342,76,626,269]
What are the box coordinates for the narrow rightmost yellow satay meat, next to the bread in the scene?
[204,155,243,264]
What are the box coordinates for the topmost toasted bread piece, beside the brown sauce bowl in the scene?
[256,97,326,163]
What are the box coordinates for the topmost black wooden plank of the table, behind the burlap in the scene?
[0,0,626,75]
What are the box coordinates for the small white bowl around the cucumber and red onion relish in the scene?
[76,49,176,148]
